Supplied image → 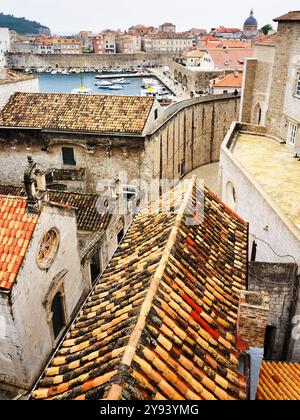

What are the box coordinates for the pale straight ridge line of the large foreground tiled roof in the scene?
[107,176,196,401]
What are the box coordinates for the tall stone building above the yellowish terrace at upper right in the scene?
[240,12,300,152]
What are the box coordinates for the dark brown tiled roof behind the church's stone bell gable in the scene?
[0,184,113,232]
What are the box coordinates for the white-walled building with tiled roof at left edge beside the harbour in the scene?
[0,69,39,109]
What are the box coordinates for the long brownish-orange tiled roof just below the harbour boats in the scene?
[0,93,154,134]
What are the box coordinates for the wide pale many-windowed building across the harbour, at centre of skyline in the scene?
[143,32,193,53]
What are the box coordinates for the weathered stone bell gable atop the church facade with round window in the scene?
[24,156,49,213]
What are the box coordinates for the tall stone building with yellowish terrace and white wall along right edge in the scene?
[220,12,300,361]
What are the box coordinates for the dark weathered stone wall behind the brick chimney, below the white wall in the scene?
[249,262,295,361]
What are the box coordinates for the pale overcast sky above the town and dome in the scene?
[0,0,300,34]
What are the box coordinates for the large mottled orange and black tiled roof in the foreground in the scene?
[32,179,248,400]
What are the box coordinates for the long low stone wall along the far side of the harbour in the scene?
[6,52,174,69]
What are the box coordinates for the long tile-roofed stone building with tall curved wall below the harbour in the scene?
[0,92,240,196]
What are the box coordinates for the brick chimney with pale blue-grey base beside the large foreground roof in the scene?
[237,291,270,401]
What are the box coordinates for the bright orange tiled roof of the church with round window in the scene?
[0,195,38,290]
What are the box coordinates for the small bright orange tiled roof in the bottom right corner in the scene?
[257,362,300,401]
